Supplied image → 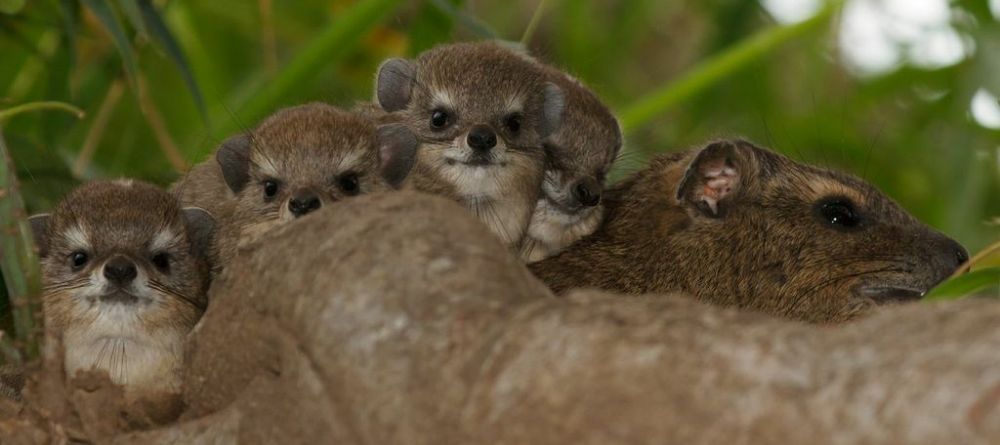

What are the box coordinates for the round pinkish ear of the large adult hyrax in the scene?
[677,141,753,218]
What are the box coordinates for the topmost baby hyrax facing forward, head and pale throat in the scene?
[376,42,563,249]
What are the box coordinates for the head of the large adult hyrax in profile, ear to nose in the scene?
[669,140,968,321]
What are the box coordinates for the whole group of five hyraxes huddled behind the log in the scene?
[13,42,966,404]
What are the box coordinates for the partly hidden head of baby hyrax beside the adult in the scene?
[542,68,622,214]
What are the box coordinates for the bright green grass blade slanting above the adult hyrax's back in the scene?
[620,1,841,133]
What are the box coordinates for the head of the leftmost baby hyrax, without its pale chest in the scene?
[30,180,215,330]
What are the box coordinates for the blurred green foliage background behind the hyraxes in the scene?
[0,0,1000,260]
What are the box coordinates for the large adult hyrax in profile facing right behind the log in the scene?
[531,140,967,321]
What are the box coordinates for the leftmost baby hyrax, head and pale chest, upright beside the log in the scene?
[31,180,214,399]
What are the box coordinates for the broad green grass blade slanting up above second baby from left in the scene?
[215,0,402,139]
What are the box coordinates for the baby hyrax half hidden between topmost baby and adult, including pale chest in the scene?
[521,65,622,262]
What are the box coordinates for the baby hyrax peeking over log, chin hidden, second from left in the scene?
[174,103,417,267]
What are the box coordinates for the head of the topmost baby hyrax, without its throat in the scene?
[376,42,563,182]
